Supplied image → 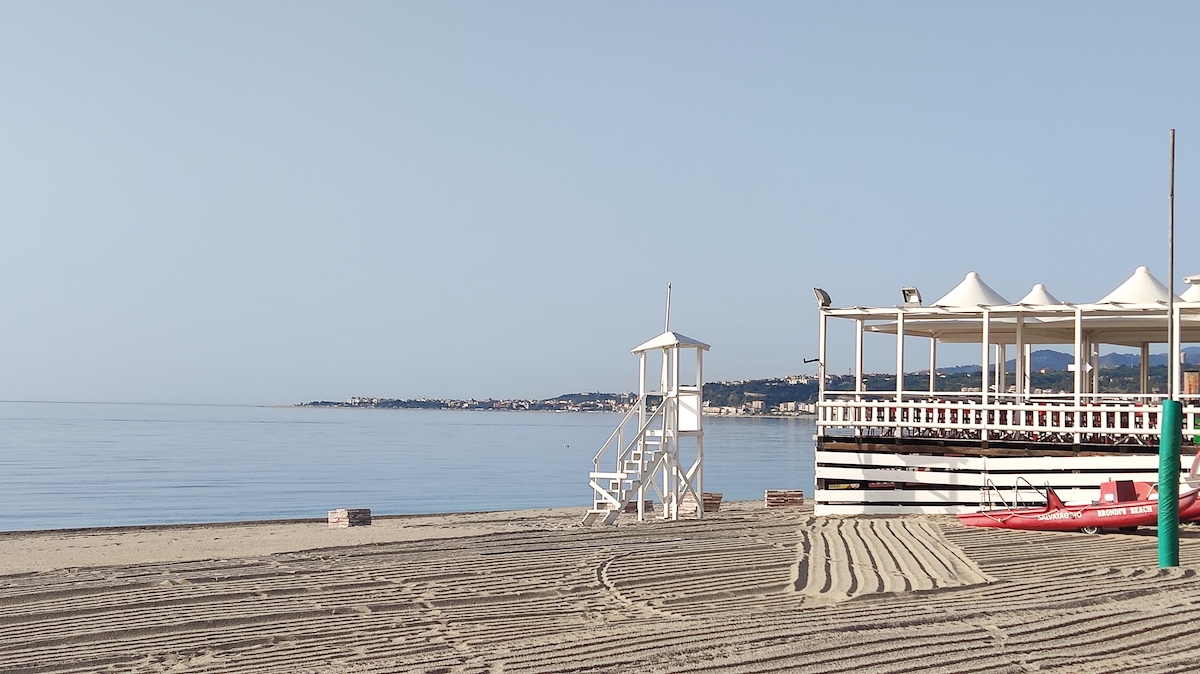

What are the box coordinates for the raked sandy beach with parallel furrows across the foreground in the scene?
[0,503,1200,673]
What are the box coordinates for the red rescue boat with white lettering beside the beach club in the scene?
[959,480,1200,534]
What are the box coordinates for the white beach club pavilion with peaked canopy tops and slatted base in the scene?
[815,266,1200,514]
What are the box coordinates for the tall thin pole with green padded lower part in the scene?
[1158,128,1183,568]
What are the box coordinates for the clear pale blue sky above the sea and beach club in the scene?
[0,1,1200,404]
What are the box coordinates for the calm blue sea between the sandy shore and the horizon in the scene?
[0,403,815,531]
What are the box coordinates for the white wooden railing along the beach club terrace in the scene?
[817,392,1200,445]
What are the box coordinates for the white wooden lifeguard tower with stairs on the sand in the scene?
[583,330,708,525]
